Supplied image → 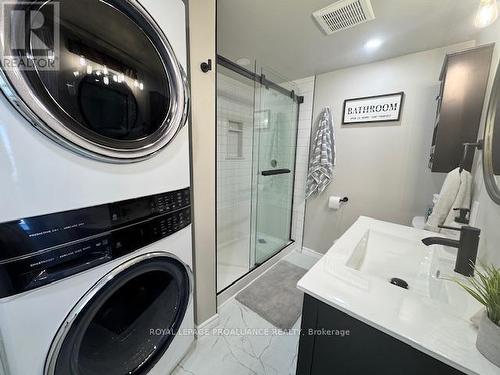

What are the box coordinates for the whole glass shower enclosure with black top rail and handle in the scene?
[217,56,301,292]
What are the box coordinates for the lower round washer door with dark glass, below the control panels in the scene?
[45,253,192,375]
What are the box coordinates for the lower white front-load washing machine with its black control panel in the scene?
[0,217,194,375]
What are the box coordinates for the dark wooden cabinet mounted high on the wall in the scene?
[429,44,494,173]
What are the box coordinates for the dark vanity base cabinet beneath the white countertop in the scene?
[297,294,463,375]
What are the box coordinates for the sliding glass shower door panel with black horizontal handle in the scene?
[251,70,298,266]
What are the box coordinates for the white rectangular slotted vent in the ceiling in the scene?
[313,0,375,35]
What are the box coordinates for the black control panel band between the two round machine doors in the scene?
[0,189,191,298]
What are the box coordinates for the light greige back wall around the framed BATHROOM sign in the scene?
[304,42,474,252]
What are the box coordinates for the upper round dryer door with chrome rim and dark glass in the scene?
[0,0,189,162]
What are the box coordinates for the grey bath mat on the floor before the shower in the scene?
[236,261,307,330]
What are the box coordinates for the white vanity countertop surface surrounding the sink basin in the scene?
[297,217,500,375]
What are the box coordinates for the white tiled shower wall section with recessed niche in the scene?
[217,72,254,290]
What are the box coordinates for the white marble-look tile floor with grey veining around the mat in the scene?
[173,252,319,375]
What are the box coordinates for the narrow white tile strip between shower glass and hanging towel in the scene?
[292,77,315,253]
